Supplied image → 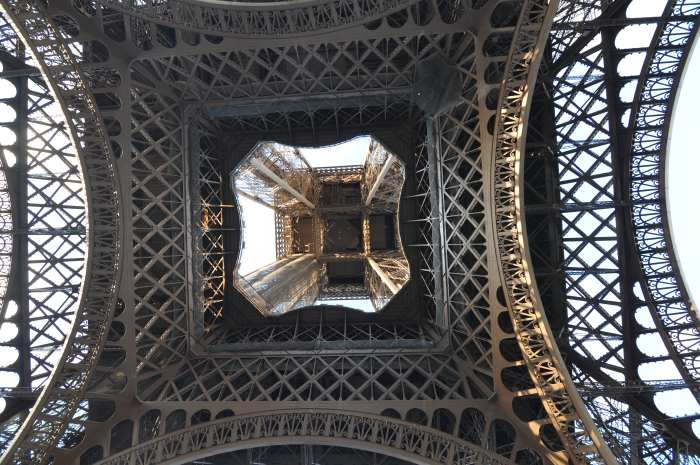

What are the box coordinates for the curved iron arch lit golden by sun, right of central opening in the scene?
[494,1,617,465]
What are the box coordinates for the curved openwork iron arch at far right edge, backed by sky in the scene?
[629,0,700,402]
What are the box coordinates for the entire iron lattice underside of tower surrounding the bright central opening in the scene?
[0,0,700,465]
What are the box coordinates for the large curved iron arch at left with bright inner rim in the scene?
[0,0,121,464]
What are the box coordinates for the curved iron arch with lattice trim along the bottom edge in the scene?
[96,409,513,465]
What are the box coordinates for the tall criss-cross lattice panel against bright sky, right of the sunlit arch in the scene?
[554,26,625,373]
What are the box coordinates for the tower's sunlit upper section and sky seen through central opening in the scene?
[230,136,410,315]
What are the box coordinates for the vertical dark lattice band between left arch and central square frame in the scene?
[131,80,188,379]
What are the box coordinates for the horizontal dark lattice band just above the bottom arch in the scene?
[150,354,469,401]
